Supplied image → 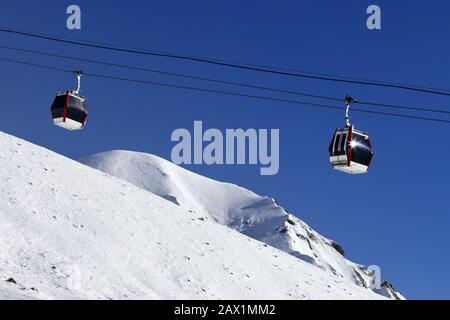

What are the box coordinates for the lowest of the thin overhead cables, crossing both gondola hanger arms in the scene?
[0,57,450,124]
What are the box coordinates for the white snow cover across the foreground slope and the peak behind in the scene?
[0,132,400,299]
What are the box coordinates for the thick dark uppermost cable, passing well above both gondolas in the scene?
[0,28,450,96]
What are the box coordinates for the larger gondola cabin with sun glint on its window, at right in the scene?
[328,95,373,174]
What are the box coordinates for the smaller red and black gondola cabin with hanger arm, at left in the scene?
[51,71,88,130]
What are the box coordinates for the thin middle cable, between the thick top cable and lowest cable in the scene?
[0,45,450,114]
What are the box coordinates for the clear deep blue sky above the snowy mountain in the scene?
[0,0,450,299]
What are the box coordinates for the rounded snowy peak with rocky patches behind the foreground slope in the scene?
[81,151,402,298]
